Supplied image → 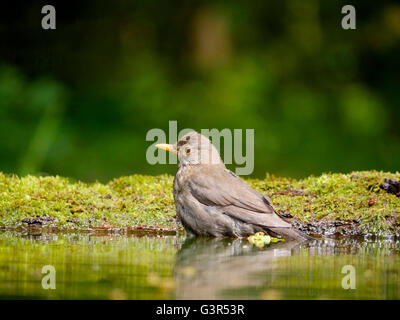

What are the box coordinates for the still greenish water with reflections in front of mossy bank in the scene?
[0,232,400,299]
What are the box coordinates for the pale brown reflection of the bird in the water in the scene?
[174,238,300,299]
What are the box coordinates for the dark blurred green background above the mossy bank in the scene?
[0,0,400,181]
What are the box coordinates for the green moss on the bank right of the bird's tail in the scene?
[251,171,400,234]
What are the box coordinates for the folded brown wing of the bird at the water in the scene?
[188,166,291,228]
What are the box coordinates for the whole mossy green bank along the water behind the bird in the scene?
[0,171,400,236]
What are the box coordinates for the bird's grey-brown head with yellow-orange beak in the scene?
[156,131,222,166]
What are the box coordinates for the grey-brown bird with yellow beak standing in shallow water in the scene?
[156,131,309,240]
